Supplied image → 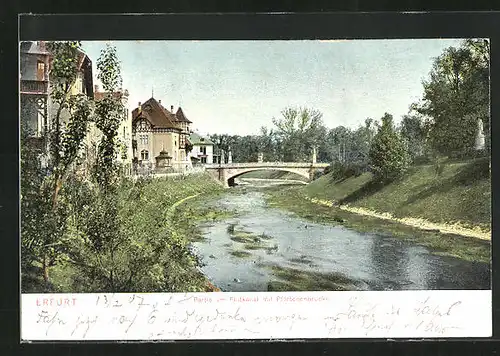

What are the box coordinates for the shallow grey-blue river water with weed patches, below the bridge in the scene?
[193,181,490,292]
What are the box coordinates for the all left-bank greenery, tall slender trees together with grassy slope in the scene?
[20,41,231,293]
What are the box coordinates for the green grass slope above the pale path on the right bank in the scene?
[303,158,491,228]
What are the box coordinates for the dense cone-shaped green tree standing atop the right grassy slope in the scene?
[369,113,410,181]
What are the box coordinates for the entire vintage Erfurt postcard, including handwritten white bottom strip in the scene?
[19,38,492,341]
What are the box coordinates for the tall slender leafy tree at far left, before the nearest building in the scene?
[21,41,92,288]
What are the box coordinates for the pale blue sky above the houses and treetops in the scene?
[83,39,461,135]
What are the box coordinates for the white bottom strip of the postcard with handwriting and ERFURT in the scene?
[21,290,492,342]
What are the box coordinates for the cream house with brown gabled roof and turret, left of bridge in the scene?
[132,98,191,171]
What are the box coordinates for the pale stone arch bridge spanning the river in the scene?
[205,162,329,187]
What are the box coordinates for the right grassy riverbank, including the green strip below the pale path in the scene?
[267,162,491,263]
